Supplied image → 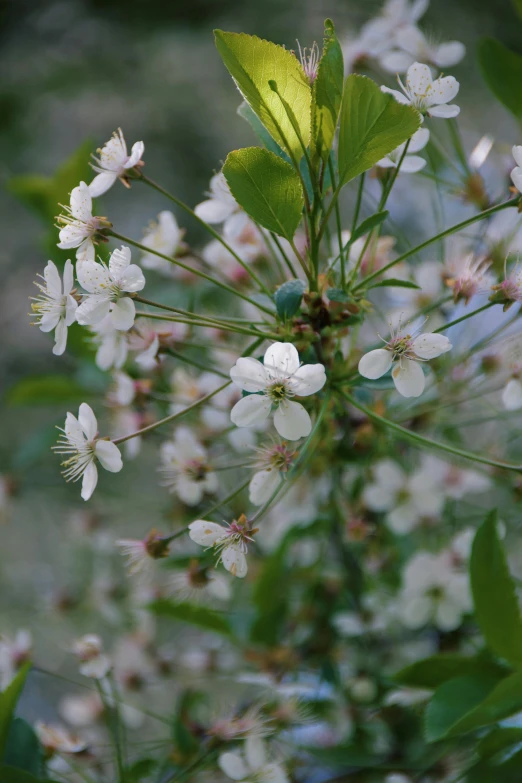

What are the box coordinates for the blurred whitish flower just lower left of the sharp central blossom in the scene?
[160,427,218,506]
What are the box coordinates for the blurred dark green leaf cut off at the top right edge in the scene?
[477,38,522,119]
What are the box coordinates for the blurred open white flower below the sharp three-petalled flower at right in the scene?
[363,459,445,534]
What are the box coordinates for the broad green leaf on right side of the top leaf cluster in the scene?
[339,74,420,185]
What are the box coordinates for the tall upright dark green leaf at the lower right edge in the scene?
[470,511,522,666]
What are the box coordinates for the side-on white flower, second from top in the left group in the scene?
[57,182,112,262]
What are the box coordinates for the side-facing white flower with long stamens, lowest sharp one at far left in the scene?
[53,402,123,500]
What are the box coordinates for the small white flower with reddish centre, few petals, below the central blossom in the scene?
[189,514,257,578]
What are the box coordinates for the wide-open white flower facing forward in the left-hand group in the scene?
[76,246,145,331]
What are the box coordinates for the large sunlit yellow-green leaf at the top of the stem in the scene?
[214,30,312,160]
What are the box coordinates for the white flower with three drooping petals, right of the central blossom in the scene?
[359,327,452,397]
